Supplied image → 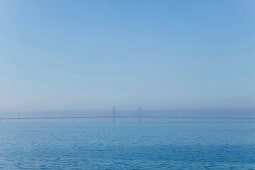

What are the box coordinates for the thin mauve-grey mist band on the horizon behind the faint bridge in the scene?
[0,108,255,119]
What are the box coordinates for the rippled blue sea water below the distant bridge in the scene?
[0,122,255,170]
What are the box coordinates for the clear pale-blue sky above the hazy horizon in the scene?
[0,0,255,112]
